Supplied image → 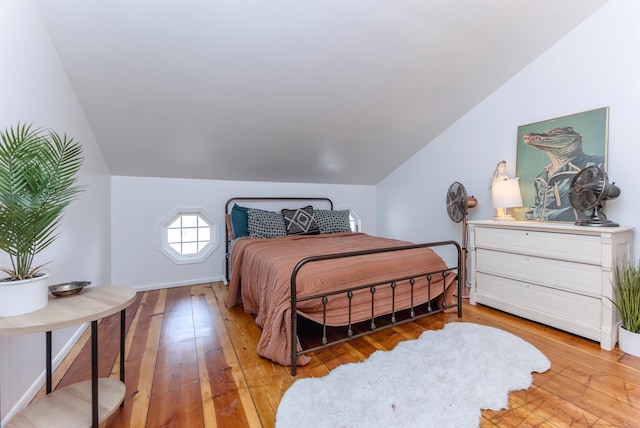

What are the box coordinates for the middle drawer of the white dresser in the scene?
[476,248,602,298]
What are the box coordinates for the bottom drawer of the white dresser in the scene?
[476,273,602,340]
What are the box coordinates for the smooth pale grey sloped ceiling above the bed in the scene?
[36,0,605,184]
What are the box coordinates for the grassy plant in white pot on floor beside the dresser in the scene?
[613,261,640,357]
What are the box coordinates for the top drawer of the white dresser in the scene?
[475,228,602,265]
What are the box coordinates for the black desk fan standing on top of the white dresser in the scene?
[569,166,620,227]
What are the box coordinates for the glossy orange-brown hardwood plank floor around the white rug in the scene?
[37,283,640,428]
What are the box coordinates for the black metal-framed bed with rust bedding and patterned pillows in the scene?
[225,198,462,376]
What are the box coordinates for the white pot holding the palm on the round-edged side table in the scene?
[0,273,49,317]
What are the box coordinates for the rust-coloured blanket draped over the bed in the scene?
[226,233,455,365]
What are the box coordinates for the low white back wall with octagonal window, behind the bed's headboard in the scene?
[111,177,376,290]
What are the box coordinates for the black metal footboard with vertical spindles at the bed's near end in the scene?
[291,241,463,376]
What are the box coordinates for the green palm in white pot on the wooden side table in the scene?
[0,124,83,316]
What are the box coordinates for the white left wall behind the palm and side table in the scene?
[0,0,110,421]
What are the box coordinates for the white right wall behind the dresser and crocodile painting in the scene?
[378,0,640,256]
